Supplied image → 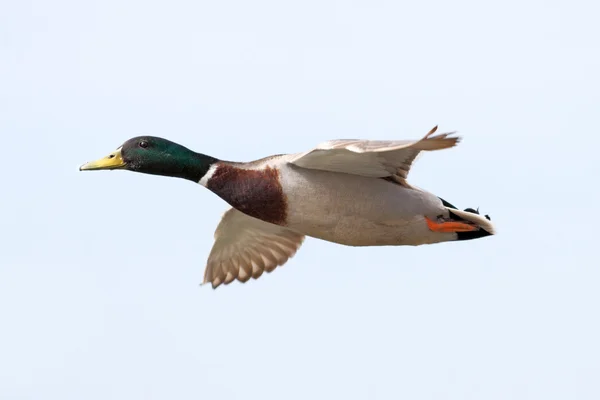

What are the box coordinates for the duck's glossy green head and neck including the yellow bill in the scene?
[79,136,218,182]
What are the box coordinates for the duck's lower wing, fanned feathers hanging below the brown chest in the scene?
[204,208,304,288]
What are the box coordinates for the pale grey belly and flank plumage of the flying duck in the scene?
[278,161,456,246]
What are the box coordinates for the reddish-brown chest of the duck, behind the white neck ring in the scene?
[207,164,287,225]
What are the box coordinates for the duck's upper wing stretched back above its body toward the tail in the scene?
[289,126,460,183]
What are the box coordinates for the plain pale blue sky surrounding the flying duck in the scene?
[0,0,600,400]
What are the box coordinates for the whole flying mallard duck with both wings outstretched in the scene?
[80,127,494,288]
